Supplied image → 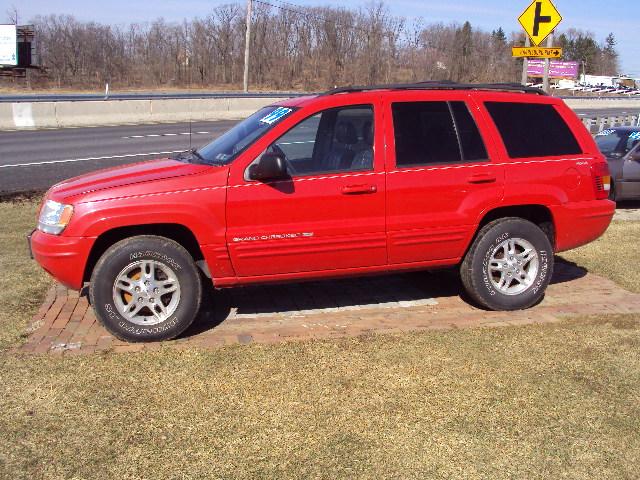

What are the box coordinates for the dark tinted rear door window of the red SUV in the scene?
[391,102,487,167]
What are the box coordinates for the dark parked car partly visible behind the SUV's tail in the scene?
[596,127,640,201]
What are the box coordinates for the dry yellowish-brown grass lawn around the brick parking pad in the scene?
[0,203,640,479]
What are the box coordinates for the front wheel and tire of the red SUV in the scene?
[89,235,202,342]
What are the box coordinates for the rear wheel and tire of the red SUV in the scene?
[460,217,554,310]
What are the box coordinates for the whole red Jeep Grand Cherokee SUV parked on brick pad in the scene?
[30,83,615,341]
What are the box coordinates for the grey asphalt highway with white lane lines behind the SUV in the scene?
[0,108,634,194]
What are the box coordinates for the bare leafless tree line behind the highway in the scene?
[23,0,619,90]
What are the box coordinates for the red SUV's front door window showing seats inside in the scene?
[268,105,373,176]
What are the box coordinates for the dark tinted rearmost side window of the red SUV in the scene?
[485,102,582,158]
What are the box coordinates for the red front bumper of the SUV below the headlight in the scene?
[27,230,95,290]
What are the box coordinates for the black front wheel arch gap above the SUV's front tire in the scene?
[82,223,206,282]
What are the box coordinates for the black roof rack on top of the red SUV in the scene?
[321,81,546,95]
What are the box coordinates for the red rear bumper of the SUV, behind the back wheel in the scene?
[551,200,616,252]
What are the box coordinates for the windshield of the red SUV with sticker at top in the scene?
[194,106,293,165]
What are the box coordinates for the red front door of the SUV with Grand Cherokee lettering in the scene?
[227,98,387,277]
